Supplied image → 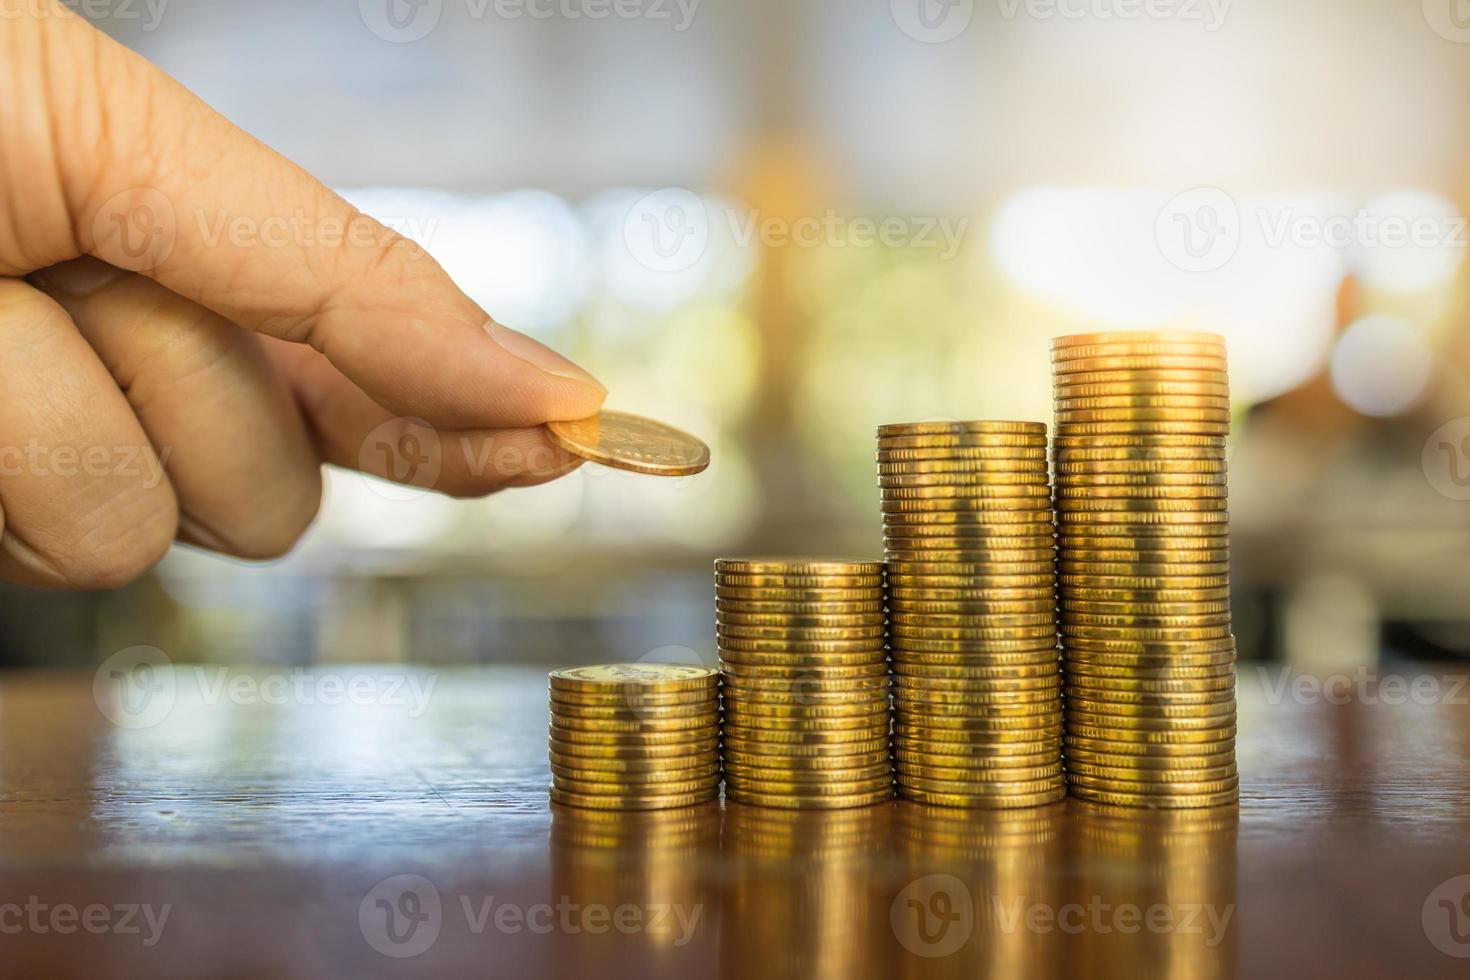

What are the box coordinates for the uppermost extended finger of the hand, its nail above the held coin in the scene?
[10,4,606,429]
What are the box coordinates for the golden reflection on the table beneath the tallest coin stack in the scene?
[1066,801,1239,980]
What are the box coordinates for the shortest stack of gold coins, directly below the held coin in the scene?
[551,664,720,810]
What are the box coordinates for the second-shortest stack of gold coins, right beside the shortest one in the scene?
[714,558,894,810]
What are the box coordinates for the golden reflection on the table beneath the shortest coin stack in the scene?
[549,804,720,977]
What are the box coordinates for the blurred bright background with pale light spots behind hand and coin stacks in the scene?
[0,0,1470,667]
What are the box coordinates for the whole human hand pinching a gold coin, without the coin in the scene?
[0,0,606,588]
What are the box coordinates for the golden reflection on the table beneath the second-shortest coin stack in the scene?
[719,802,892,980]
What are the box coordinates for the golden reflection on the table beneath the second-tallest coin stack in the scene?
[889,802,1066,980]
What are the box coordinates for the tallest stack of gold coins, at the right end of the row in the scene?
[1051,332,1239,808]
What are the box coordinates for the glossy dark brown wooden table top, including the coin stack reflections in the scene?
[0,667,1470,980]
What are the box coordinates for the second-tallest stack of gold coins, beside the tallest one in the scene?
[878,422,1066,807]
